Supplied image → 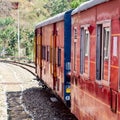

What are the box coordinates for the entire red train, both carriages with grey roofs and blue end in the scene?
[35,0,120,120]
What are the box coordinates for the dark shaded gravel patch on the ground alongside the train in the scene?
[22,88,77,120]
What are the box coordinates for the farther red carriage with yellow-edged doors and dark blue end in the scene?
[35,11,71,106]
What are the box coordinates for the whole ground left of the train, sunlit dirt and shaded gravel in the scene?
[0,62,77,120]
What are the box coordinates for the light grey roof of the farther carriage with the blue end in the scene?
[35,12,66,28]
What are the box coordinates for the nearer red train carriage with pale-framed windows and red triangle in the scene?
[71,0,120,120]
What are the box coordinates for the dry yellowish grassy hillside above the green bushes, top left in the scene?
[0,0,49,28]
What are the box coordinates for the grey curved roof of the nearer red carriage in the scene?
[72,0,109,15]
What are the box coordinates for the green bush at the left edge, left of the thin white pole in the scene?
[0,17,16,55]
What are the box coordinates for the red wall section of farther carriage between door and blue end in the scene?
[55,21,64,100]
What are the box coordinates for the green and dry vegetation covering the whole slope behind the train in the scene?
[0,0,85,58]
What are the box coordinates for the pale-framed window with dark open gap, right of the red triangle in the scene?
[96,22,110,85]
